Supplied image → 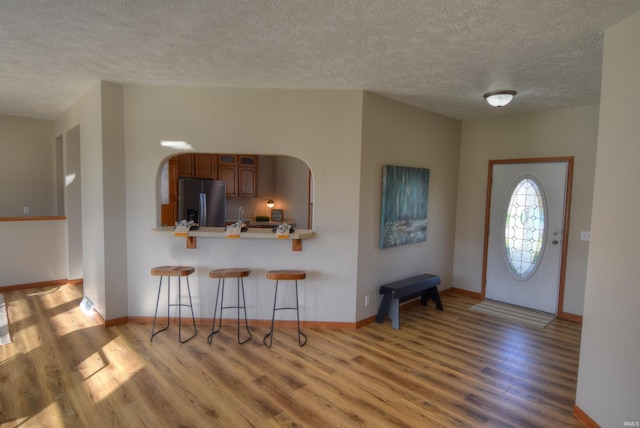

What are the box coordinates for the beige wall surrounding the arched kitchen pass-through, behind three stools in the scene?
[122,86,362,322]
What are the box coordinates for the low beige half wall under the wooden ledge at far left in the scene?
[0,219,68,287]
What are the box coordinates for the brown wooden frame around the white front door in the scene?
[480,156,574,318]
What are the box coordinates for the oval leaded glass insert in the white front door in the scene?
[503,177,546,281]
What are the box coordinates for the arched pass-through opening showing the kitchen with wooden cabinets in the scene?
[157,153,314,229]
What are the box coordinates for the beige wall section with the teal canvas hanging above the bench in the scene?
[360,92,461,320]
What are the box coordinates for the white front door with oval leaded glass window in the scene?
[485,162,567,314]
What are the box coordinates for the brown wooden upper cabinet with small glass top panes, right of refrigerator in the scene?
[218,154,258,197]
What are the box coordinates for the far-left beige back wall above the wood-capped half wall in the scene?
[0,115,57,217]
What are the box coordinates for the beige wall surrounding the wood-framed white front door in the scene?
[453,105,598,315]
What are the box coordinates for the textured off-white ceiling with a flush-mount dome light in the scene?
[0,0,640,119]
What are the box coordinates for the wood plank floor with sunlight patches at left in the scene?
[0,285,581,428]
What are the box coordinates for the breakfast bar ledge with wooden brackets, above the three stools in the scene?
[151,226,315,251]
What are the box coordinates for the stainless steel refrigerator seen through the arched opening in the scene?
[178,178,226,227]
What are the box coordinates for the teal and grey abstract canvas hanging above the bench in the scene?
[380,165,429,248]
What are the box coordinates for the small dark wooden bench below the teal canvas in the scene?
[376,273,444,330]
